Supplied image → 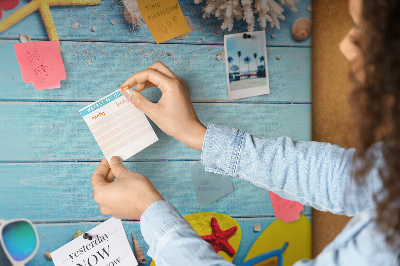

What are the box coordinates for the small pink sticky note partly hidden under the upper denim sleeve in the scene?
[269,191,304,223]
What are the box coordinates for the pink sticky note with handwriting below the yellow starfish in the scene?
[14,41,67,90]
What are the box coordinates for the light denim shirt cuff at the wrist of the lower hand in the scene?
[140,200,191,259]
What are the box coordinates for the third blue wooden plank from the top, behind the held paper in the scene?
[0,102,311,162]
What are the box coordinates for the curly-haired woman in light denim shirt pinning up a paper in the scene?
[92,0,400,265]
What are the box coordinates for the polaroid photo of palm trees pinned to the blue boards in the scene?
[224,31,269,100]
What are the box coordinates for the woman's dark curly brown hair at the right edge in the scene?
[350,0,400,251]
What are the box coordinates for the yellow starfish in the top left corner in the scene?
[0,0,101,41]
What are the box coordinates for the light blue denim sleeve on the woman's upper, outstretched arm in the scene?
[201,124,381,216]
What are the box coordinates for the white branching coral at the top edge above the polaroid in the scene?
[194,0,300,31]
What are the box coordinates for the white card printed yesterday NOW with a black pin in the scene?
[51,218,138,266]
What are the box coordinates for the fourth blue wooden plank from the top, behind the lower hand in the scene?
[0,161,311,221]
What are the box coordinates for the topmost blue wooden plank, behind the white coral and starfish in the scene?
[0,0,312,46]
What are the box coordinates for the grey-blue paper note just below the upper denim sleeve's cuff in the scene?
[190,162,233,208]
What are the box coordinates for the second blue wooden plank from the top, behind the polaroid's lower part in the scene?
[0,41,311,102]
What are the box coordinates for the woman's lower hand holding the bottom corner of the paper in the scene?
[92,157,164,219]
